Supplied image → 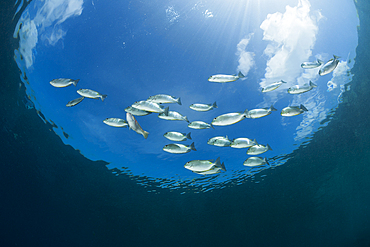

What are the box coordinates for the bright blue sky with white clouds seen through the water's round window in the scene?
[16,0,358,189]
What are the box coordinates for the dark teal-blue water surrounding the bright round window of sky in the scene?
[0,0,370,246]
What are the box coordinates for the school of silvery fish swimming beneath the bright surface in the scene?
[50,55,340,175]
